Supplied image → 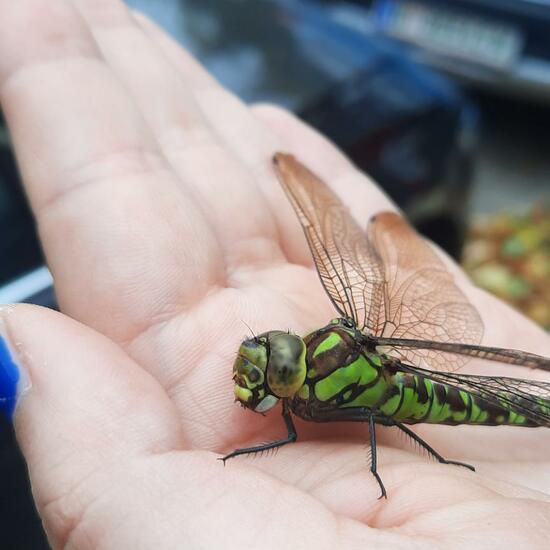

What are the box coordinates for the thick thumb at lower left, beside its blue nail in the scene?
[0,305,185,548]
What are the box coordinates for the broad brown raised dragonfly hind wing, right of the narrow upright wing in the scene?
[368,212,483,370]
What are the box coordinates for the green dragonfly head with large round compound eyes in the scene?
[233,330,307,413]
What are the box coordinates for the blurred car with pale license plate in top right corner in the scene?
[334,0,550,103]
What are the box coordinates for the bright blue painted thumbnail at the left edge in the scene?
[0,308,30,419]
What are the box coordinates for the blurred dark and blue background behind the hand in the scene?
[0,0,550,549]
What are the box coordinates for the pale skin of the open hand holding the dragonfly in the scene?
[0,0,550,550]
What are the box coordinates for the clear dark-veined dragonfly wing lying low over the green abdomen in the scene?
[399,365,550,428]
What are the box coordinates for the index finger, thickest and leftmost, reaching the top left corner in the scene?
[0,0,220,341]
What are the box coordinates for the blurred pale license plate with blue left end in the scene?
[374,0,523,69]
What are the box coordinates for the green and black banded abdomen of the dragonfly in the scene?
[386,372,536,426]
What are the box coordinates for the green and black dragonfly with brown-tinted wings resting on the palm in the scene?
[222,153,550,498]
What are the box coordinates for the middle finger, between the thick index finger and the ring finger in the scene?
[74,0,282,270]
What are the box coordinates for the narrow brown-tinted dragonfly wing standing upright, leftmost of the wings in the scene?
[274,153,385,332]
